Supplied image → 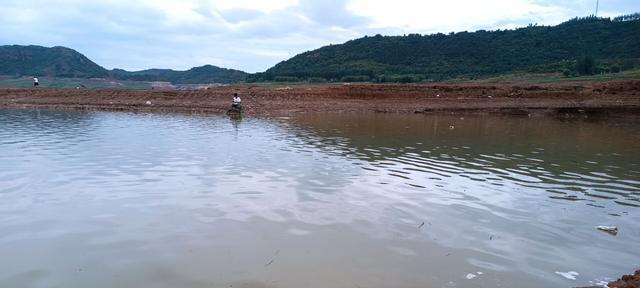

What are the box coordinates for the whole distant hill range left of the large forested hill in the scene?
[0,45,247,84]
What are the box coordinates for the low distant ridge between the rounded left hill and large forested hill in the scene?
[111,65,247,84]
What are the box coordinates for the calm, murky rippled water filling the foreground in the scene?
[0,110,640,287]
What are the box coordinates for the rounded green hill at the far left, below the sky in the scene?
[0,45,109,78]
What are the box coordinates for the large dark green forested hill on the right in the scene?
[255,14,640,82]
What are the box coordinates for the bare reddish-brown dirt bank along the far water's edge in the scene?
[0,80,640,115]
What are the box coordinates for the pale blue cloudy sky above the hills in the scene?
[0,0,640,72]
